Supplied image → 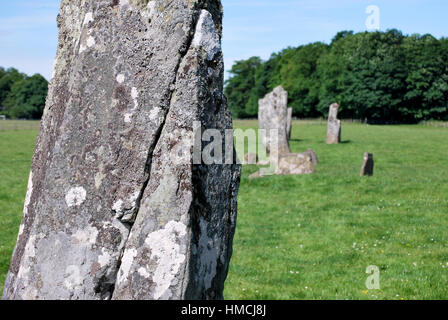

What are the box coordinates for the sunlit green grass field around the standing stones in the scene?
[0,121,448,300]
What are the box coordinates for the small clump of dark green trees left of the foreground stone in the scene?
[0,68,48,119]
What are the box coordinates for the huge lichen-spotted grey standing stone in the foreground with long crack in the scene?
[3,0,240,300]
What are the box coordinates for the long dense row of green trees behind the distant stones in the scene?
[225,30,448,122]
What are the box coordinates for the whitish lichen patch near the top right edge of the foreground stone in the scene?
[192,10,221,60]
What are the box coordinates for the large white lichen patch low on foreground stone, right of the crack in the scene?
[145,221,187,299]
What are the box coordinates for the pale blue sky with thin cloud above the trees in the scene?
[0,0,448,80]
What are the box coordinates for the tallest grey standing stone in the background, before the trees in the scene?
[258,86,290,154]
